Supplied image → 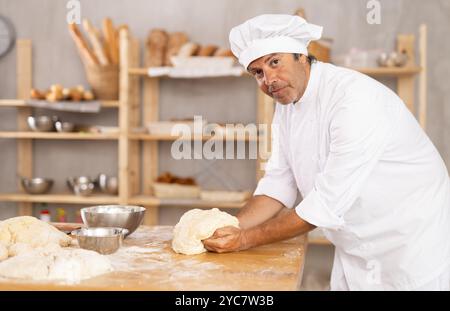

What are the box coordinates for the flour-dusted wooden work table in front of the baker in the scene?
[0,226,306,290]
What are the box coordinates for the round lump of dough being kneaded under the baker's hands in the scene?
[172,208,239,255]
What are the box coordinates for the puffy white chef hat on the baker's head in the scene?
[230,14,322,69]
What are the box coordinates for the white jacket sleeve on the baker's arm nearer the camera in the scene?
[296,99,395,229]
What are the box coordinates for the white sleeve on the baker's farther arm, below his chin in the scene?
[253,104,297,208]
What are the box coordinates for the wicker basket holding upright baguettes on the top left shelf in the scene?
[84,64,119,100]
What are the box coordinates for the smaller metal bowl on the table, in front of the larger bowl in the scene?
[72,227,128,255]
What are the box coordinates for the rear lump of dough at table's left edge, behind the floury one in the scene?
[0,216,72,252]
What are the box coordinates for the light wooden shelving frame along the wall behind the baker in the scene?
[0,25,426,245]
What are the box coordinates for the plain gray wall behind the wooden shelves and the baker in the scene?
[0,0,450,224]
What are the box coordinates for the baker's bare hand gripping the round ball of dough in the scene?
[202,226,250,253]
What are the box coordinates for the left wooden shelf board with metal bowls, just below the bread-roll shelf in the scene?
[0,131,119,140]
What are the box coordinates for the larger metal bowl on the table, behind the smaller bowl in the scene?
[81,205,145,236]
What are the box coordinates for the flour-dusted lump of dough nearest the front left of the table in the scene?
[0,244,113,283]
